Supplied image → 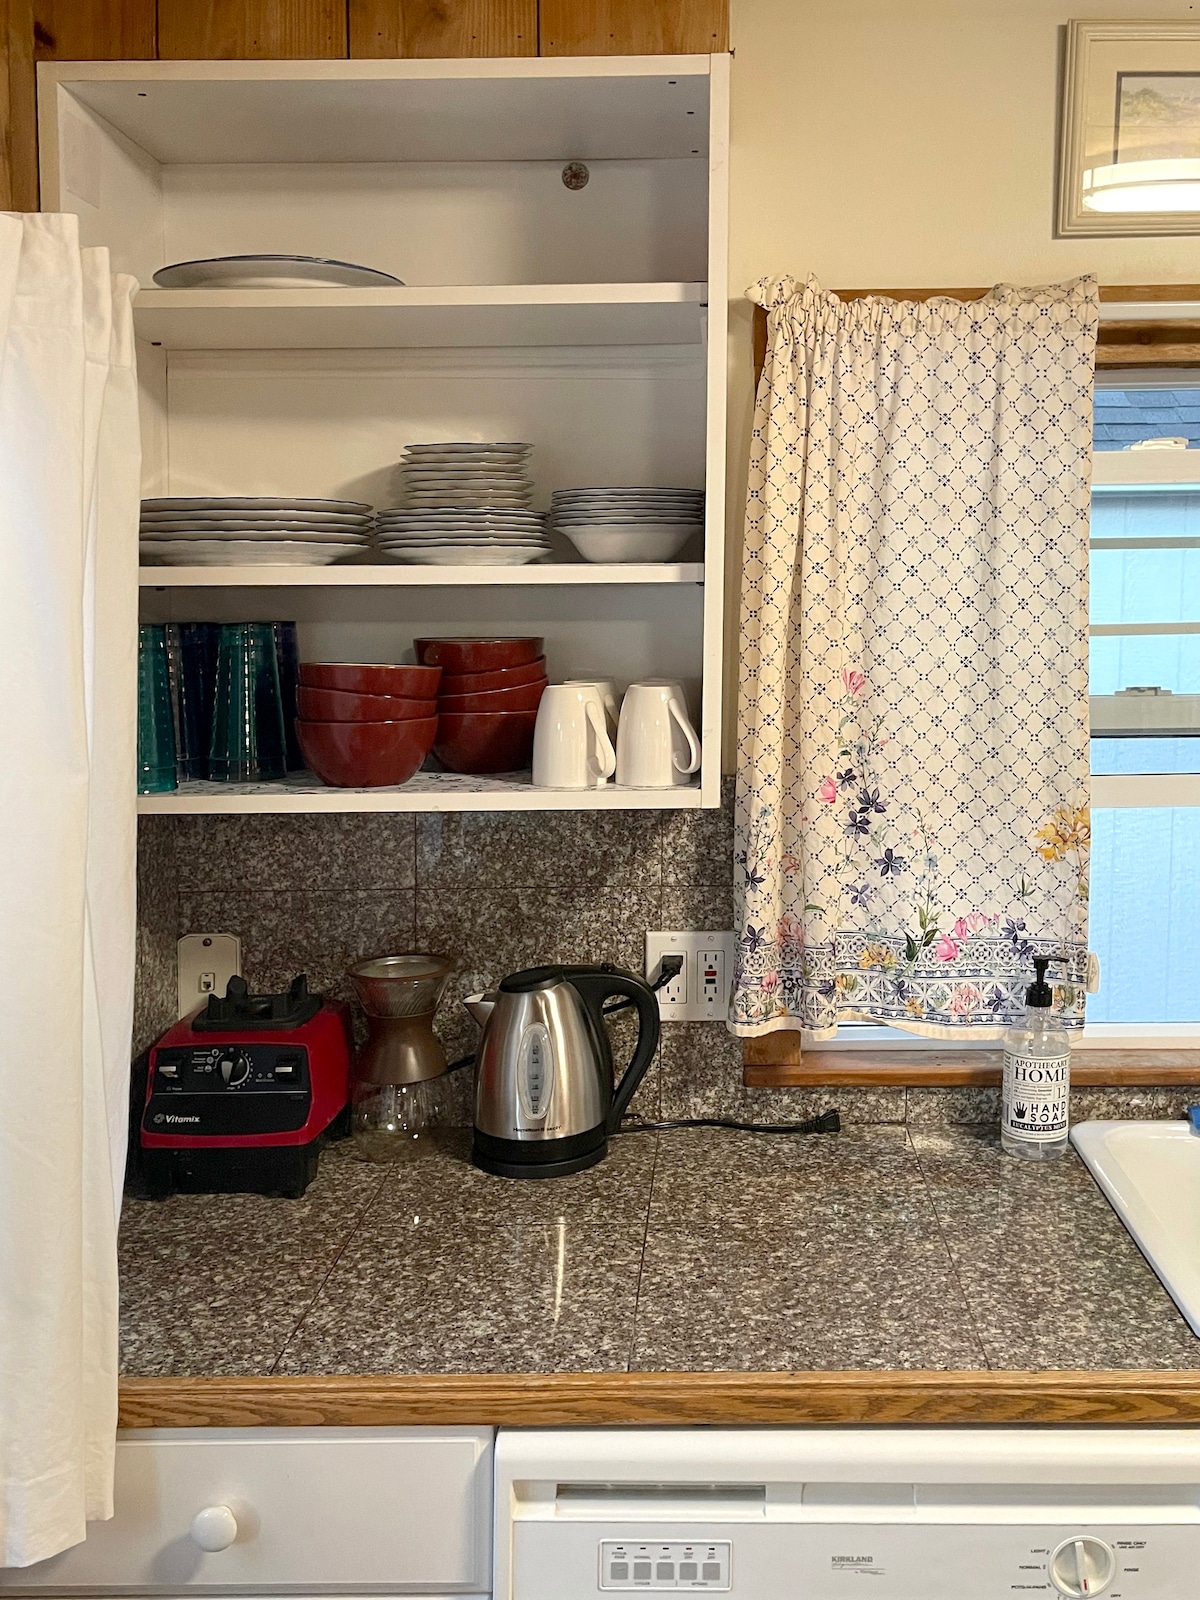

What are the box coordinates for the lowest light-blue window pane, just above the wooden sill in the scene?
[1088,806,1200,1022]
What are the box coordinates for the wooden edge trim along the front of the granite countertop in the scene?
[118,1370,1200,1429]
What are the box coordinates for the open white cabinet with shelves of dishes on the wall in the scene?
[38,56,728,813]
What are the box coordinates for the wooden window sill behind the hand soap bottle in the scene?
[742,1030,1200,1090]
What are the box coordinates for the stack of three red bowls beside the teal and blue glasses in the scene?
[296,661,442,789]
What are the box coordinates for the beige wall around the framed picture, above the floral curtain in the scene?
[726,0,1200,765]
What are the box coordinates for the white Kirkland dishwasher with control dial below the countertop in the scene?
[493,1427,1200,1600]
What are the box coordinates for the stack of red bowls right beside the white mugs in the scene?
[414,638,547,773]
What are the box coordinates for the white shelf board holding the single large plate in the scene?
[134,283,709,350]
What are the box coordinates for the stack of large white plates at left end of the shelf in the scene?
[139,494,374,566]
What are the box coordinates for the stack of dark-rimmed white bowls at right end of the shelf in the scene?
[550,488,704,562]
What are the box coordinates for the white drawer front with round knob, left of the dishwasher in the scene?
[0,1427,493,1595]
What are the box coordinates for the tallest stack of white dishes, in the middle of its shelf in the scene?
[378,442,549,566]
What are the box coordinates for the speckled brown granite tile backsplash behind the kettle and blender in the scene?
[134,779,1194,1128]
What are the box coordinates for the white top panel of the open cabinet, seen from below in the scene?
[47,56,710,163]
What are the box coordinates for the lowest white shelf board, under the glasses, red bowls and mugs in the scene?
[138,773,701,816]
